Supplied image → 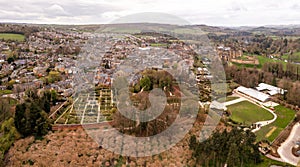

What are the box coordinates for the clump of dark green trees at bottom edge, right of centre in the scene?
[189,128,262,167]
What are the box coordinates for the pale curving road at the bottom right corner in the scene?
[277,122,300,166]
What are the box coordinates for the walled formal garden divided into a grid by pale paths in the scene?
[54,87,116,124]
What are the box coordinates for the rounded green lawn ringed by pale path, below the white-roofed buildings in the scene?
[227,101,273,125]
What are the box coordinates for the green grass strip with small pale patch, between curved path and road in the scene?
[256,106,296,142]
